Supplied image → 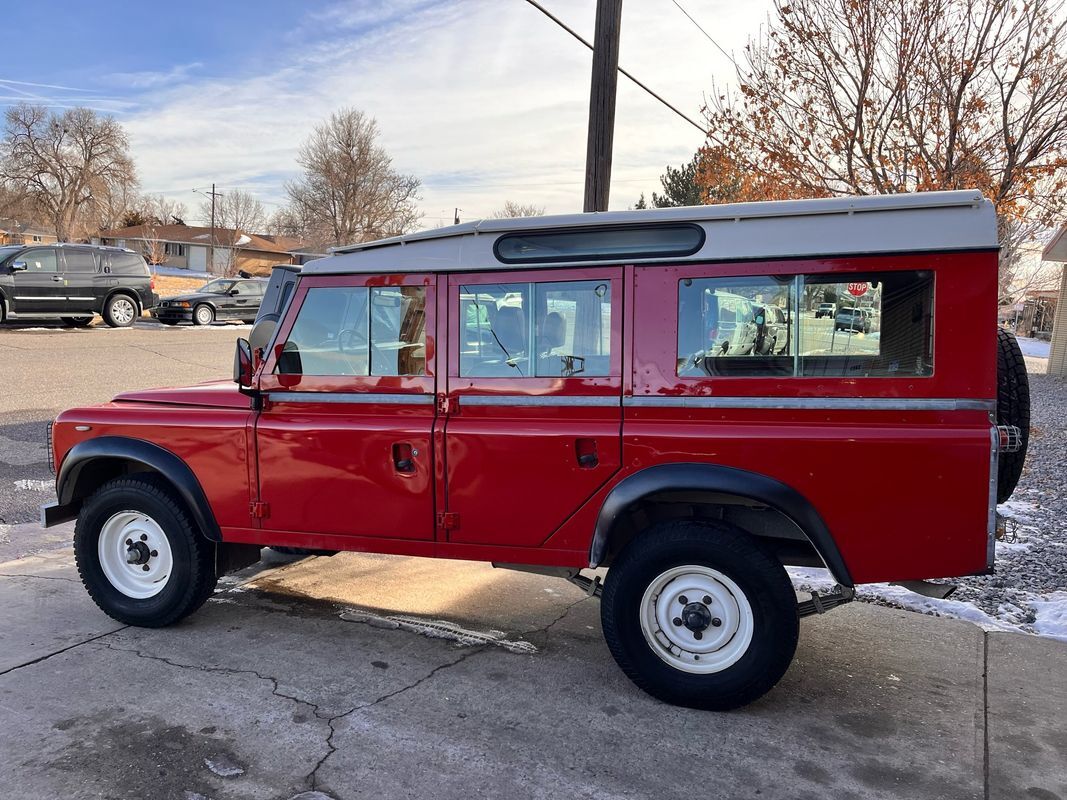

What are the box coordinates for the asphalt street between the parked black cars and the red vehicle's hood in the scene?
[0,319,241,533]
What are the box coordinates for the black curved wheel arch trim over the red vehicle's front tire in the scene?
[55,436,222,542]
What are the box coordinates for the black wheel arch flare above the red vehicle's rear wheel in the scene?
[589,463,853,587]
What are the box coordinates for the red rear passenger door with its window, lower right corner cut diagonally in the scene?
[439,267,623,547]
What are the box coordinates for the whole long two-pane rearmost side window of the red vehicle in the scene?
[678,271,934,378]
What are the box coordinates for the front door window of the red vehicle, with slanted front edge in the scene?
[275,286,426,377]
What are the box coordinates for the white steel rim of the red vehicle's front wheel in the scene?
[97,511,174,599]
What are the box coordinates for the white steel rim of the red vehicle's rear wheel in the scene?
[639,564,754,674]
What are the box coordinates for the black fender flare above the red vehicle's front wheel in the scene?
[55,436,222,542]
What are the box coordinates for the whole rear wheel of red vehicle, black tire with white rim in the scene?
[601,521,799,711]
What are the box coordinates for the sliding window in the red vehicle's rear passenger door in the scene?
[459,281,611,378]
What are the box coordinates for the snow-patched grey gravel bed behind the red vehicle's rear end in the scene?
[790,360,1067,642]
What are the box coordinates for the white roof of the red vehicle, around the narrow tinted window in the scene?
[303,190,998,275]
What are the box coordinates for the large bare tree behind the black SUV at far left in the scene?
[0,103,136,241]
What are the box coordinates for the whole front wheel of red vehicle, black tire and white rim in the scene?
[74,477,218,627]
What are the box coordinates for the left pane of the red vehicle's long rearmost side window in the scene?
[678,276,796,378]
